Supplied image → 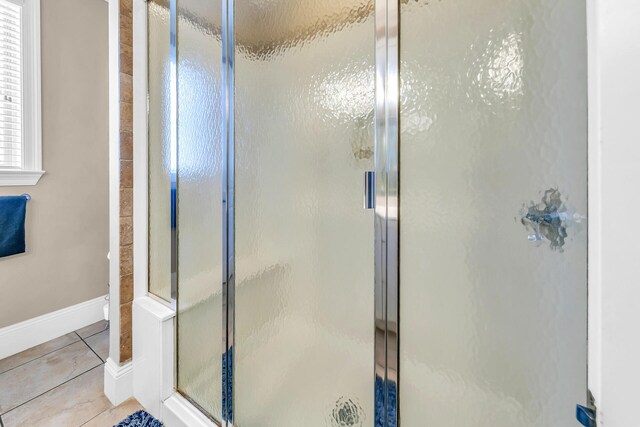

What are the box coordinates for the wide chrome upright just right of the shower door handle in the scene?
[374,0,400,427]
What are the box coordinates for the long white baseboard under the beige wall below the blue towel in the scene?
[0,296,107,359]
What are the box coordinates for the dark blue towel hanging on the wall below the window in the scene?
[0,196,27,257]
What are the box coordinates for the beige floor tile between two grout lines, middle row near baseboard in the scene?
[0,341,102,414]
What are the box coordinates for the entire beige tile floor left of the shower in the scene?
[0,322,142,427]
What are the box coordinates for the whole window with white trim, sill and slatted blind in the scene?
[0,0,44,186]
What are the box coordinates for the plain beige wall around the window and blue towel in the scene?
[0,0,109,328]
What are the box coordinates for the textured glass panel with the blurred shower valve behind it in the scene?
[400,0,587,427]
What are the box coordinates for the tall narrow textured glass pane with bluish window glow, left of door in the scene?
[177,0,223,419]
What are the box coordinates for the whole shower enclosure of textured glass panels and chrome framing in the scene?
[147,0,589,427]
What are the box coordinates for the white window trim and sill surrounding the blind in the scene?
[0,0,44,186]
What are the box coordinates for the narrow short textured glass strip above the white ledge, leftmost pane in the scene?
[147,0,172,301]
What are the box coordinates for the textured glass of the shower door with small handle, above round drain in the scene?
[233,0,374,427]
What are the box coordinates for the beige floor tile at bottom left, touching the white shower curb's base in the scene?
[2,365,111,427]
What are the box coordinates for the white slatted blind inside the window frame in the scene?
[0,0,24,170]
